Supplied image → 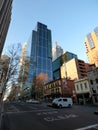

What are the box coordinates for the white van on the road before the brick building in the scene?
[52,97,73,108]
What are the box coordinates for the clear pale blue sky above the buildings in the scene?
[3,0,98,62]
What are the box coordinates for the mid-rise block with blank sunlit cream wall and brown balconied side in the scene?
[61,58,90,80]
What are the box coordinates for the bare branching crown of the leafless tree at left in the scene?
[2,43,21,93]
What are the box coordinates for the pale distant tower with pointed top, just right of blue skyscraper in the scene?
[52,42,63,61]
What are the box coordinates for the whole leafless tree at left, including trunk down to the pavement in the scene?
[0,43,21,127]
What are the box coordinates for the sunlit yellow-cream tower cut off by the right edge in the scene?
[85,27,98,67]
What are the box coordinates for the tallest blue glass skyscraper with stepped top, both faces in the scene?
[25,22,52,91]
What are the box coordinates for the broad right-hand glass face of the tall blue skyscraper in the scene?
[36,23,52,80]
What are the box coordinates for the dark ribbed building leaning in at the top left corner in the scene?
[0,0,12,56]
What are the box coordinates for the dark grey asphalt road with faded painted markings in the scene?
[1,102,98,130]
